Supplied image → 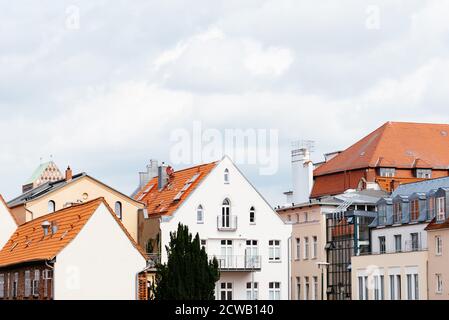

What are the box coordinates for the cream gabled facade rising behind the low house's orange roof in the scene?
[10,175,144,242]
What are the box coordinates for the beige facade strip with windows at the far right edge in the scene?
[427,229,449,300]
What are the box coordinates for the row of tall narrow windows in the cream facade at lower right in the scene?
[358,273,419,300]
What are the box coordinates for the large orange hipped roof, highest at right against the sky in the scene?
[314,122,449,176]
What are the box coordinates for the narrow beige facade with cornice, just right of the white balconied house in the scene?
[278,204,335,300]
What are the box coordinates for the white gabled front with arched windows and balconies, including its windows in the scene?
[161,157,291,300]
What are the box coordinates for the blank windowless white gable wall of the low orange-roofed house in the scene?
[54,204,146,300]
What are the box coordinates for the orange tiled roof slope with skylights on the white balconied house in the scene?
[134,162,217,215]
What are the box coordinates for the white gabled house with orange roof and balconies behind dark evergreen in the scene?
[136,157,291,300]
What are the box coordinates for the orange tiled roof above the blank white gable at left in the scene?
[0,198,146,267]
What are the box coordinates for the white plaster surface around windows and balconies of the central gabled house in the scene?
[161,158,291,300]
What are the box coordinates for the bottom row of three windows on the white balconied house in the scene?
[218,282,281,300]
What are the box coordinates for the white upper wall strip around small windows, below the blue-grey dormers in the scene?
[371,223,427,253]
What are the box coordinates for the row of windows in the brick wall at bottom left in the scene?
[0,270,52,299]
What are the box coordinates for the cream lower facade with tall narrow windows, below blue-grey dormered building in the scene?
[351,250,428,300]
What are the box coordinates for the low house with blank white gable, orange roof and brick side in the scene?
[0,198,147,300]
